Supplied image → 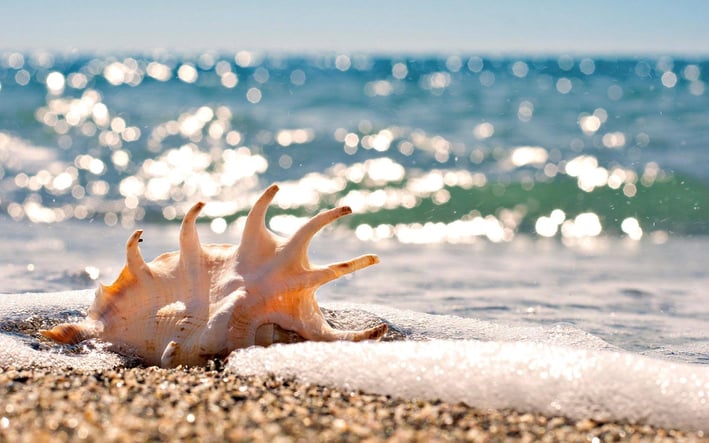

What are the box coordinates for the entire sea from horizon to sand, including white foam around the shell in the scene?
[0,51,709,430]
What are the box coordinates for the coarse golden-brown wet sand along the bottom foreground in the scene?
[0,366,709,442]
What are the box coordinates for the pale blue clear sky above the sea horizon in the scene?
[0,0,709,55]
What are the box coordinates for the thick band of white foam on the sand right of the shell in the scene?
[227,340,709,432]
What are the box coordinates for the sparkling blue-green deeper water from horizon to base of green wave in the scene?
[0,52,709,243]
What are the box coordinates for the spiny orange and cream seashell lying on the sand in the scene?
[40,185,387,367]
